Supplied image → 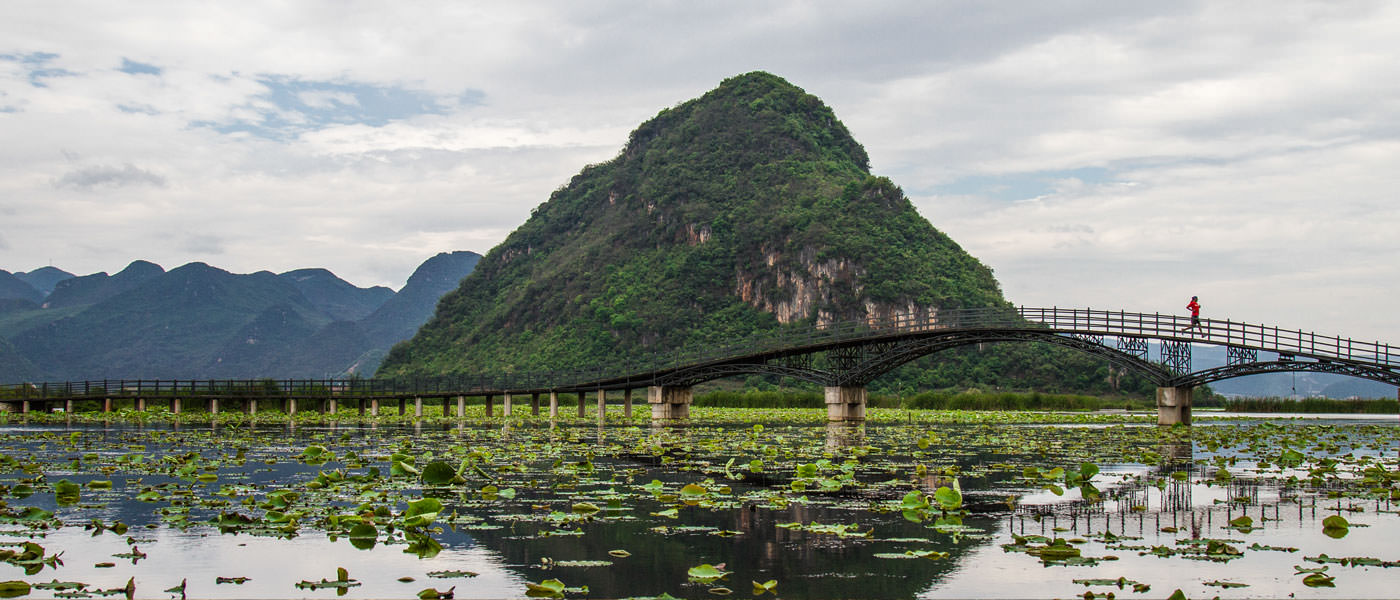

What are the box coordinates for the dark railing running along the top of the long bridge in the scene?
[0,306,1400,400]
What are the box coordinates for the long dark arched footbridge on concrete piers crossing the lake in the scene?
[0,306,1400,425]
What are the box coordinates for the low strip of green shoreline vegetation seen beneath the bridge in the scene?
[0,389,1400,425]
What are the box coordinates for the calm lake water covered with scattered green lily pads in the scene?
[0,422,1400,599]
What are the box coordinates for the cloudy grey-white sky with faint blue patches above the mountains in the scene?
[0,0,1400,343]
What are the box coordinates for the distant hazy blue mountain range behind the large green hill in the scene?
[0,252,482,383]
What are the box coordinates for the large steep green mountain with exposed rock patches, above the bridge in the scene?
[381,73,1004,375]
